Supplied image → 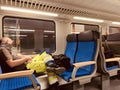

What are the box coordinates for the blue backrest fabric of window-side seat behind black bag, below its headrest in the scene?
[65,42,77,65]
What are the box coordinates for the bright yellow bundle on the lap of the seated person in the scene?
[26,52,46,73]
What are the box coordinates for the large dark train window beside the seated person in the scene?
[3,17,56,54]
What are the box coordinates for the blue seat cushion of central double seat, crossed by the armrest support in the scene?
[60,67,91,82]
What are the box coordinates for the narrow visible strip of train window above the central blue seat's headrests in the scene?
[71,23,99,33]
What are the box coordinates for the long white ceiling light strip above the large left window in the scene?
[1,6,58,17]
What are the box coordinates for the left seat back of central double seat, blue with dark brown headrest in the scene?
[64,34,77,65]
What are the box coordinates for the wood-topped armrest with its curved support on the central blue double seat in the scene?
[72,61,96,79]
